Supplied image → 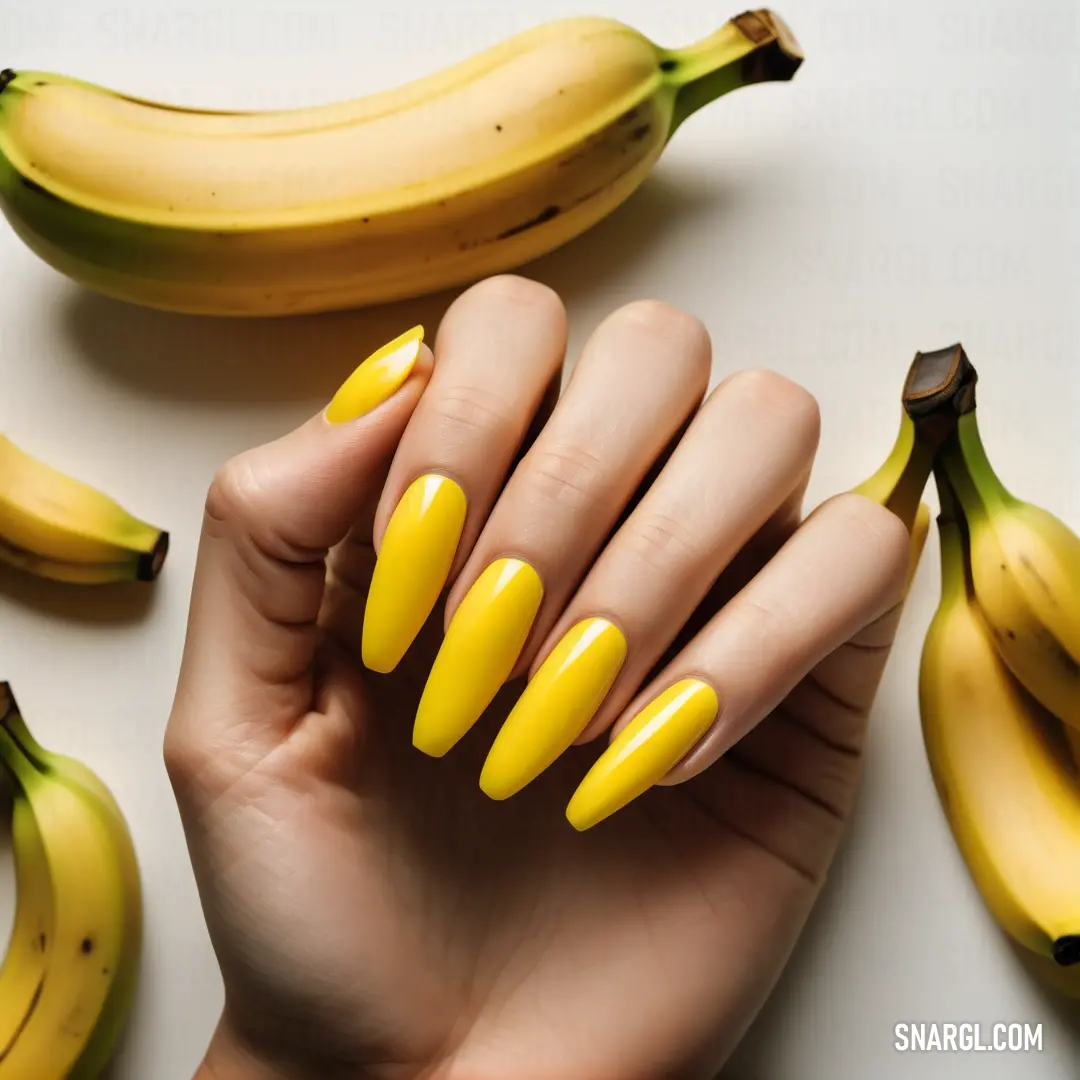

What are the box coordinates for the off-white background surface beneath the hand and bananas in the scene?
[0,0,1080,1080]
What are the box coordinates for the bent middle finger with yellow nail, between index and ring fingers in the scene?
[413,301,710,756]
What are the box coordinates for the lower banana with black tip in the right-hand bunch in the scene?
[919,501,1080,968]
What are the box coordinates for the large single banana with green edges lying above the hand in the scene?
[0,10,802,315]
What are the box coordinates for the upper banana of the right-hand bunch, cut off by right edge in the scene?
[941,405,1080,728]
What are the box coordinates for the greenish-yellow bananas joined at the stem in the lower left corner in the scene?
[0,683,143,1080]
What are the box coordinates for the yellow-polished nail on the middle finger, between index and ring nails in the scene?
[413,558,543,757]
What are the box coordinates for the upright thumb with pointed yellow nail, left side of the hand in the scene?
[166,326,432,764]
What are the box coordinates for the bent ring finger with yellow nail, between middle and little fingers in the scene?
[481,372,819,798]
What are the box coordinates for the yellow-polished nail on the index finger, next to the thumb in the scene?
[361,474,465,674]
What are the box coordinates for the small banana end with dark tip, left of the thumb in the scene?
[0,435,168,584]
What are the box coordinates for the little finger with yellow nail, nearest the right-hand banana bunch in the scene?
[567,495,909,829]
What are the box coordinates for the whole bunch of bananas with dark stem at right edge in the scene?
[863,345,1080,998]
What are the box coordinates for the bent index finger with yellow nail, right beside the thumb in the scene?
[361,274,566,673]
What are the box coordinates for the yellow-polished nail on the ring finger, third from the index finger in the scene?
[480,619,626,799]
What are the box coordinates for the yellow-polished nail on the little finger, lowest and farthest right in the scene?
[566,678,719,831]
